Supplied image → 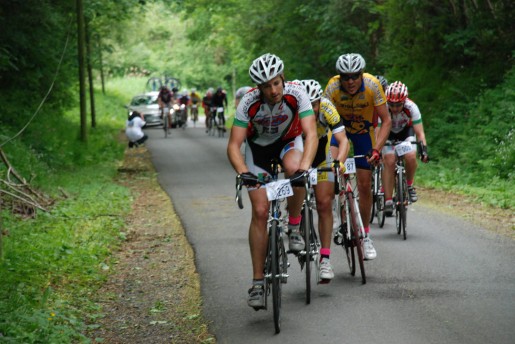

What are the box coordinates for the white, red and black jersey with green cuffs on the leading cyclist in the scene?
[234,82,314,146]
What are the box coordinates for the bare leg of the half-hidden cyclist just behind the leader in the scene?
[315,181,334,248]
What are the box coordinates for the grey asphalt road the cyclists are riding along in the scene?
[146,123,515,344]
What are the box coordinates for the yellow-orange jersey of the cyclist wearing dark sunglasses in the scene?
[324,73,386,136]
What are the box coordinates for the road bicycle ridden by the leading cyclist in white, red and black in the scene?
[236,160,293,333]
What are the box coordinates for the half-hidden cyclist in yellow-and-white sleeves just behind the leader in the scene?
[301,80,349,283]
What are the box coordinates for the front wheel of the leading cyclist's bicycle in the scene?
[270,221,282,333]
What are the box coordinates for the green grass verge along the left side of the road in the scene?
[0,82,132,343]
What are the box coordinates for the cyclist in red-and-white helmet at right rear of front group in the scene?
[380,81,429,216]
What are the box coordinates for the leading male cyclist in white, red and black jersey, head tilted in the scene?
[227,54,318,308]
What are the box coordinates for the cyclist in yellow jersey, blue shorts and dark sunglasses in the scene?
[324,54,391,260]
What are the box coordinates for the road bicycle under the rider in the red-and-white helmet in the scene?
[387,141,415,240]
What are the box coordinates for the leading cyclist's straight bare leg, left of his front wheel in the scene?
[249,188,269,279]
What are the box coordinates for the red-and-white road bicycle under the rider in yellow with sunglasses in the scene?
[333,155,367,284]
